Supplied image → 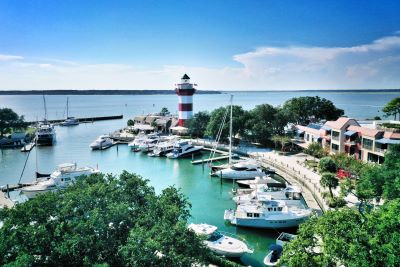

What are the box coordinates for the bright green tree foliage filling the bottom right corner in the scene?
[279,200,400,267]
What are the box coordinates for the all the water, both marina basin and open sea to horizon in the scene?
[0,92,399,266]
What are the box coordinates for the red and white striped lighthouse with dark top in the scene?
[175,74,197,126]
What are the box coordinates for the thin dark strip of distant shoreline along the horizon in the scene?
[0,88,400,95]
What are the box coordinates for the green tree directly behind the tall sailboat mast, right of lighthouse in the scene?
[206,105,249,140]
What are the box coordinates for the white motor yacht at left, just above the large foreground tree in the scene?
[21,163,98,198]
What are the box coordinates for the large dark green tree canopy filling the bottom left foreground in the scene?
[0,171,222,266]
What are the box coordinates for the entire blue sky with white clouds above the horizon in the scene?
[0,0,400,90]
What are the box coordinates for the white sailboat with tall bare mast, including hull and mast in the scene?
[213,95,265,180]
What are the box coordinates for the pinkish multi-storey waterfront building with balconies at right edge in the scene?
[295,117,400,163]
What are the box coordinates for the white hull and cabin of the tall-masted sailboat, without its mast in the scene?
[215,162,265,180]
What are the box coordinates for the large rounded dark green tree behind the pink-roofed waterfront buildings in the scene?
[282,96,344,125]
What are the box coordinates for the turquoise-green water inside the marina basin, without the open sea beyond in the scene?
[0,120,294,266]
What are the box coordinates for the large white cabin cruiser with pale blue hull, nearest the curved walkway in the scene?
[224,200,312,229]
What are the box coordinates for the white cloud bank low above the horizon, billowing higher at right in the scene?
[0,34,400,90]
